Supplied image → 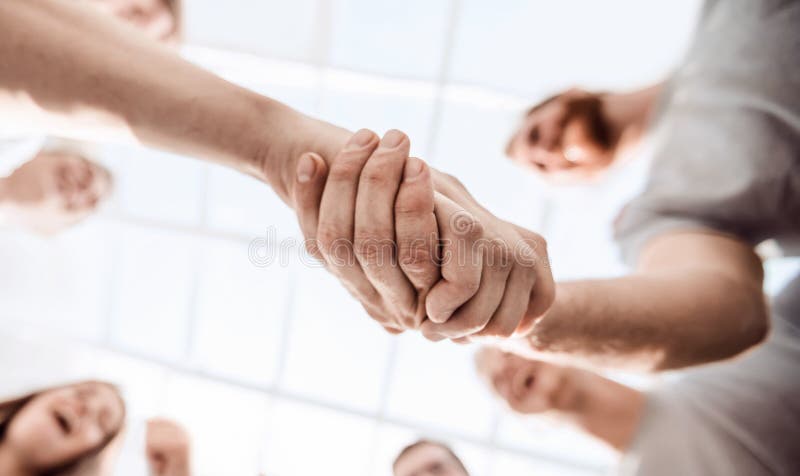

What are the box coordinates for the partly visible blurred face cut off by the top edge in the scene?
[92,0,178,41]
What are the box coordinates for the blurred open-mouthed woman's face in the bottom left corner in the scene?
[4,383,125,470]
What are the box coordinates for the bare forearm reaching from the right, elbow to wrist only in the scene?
[525,272,766,370]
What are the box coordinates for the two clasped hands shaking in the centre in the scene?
[290,129,555,342]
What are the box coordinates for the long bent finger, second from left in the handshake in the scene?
[317,129,380,302]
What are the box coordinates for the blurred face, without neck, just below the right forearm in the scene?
[475,347,578,414]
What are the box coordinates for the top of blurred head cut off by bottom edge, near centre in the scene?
[392,439,469,476]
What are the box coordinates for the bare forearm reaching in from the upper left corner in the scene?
[0,0,346,203]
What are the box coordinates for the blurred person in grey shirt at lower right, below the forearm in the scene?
[476,277,800,476]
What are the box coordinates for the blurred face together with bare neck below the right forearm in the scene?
[476,348,645,452]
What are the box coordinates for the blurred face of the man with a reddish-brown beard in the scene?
[507,91,613,181]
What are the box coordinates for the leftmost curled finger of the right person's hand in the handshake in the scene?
[425,193,483,324]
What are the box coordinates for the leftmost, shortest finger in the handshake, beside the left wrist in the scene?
[293,152,328,259]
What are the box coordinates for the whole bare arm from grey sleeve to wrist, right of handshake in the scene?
[516,231,768,370]
